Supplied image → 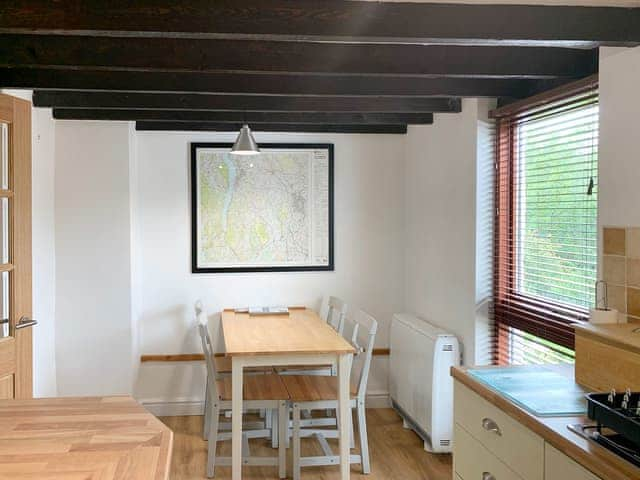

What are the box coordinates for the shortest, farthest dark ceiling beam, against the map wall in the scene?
[136,122,407,134]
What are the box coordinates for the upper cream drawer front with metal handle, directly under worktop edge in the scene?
[454,382,544,480]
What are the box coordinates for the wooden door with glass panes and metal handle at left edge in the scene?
[0,94,35,399]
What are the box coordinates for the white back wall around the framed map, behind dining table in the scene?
[136,133,404,408]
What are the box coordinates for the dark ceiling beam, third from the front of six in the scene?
[0,68,566,98]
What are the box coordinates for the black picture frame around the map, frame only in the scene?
[190,142,335,273]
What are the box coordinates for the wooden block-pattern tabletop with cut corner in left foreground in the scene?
[0,397,173,480]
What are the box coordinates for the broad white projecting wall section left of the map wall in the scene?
[55,121,133,396]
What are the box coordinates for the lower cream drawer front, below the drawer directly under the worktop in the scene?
[453,424,522,480]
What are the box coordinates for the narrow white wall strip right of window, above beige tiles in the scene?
[598,47,640,231]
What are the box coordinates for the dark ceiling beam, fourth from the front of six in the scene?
[33,90,461,113]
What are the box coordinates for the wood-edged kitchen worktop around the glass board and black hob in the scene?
[451,367,640,480]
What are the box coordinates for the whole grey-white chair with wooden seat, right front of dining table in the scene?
[281,312,378,480]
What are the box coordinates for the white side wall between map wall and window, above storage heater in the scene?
[404,99,496,364]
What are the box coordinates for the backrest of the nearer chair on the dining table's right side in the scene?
[343,310,378,401]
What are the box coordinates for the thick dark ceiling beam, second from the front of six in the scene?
[0,35,598,78]
